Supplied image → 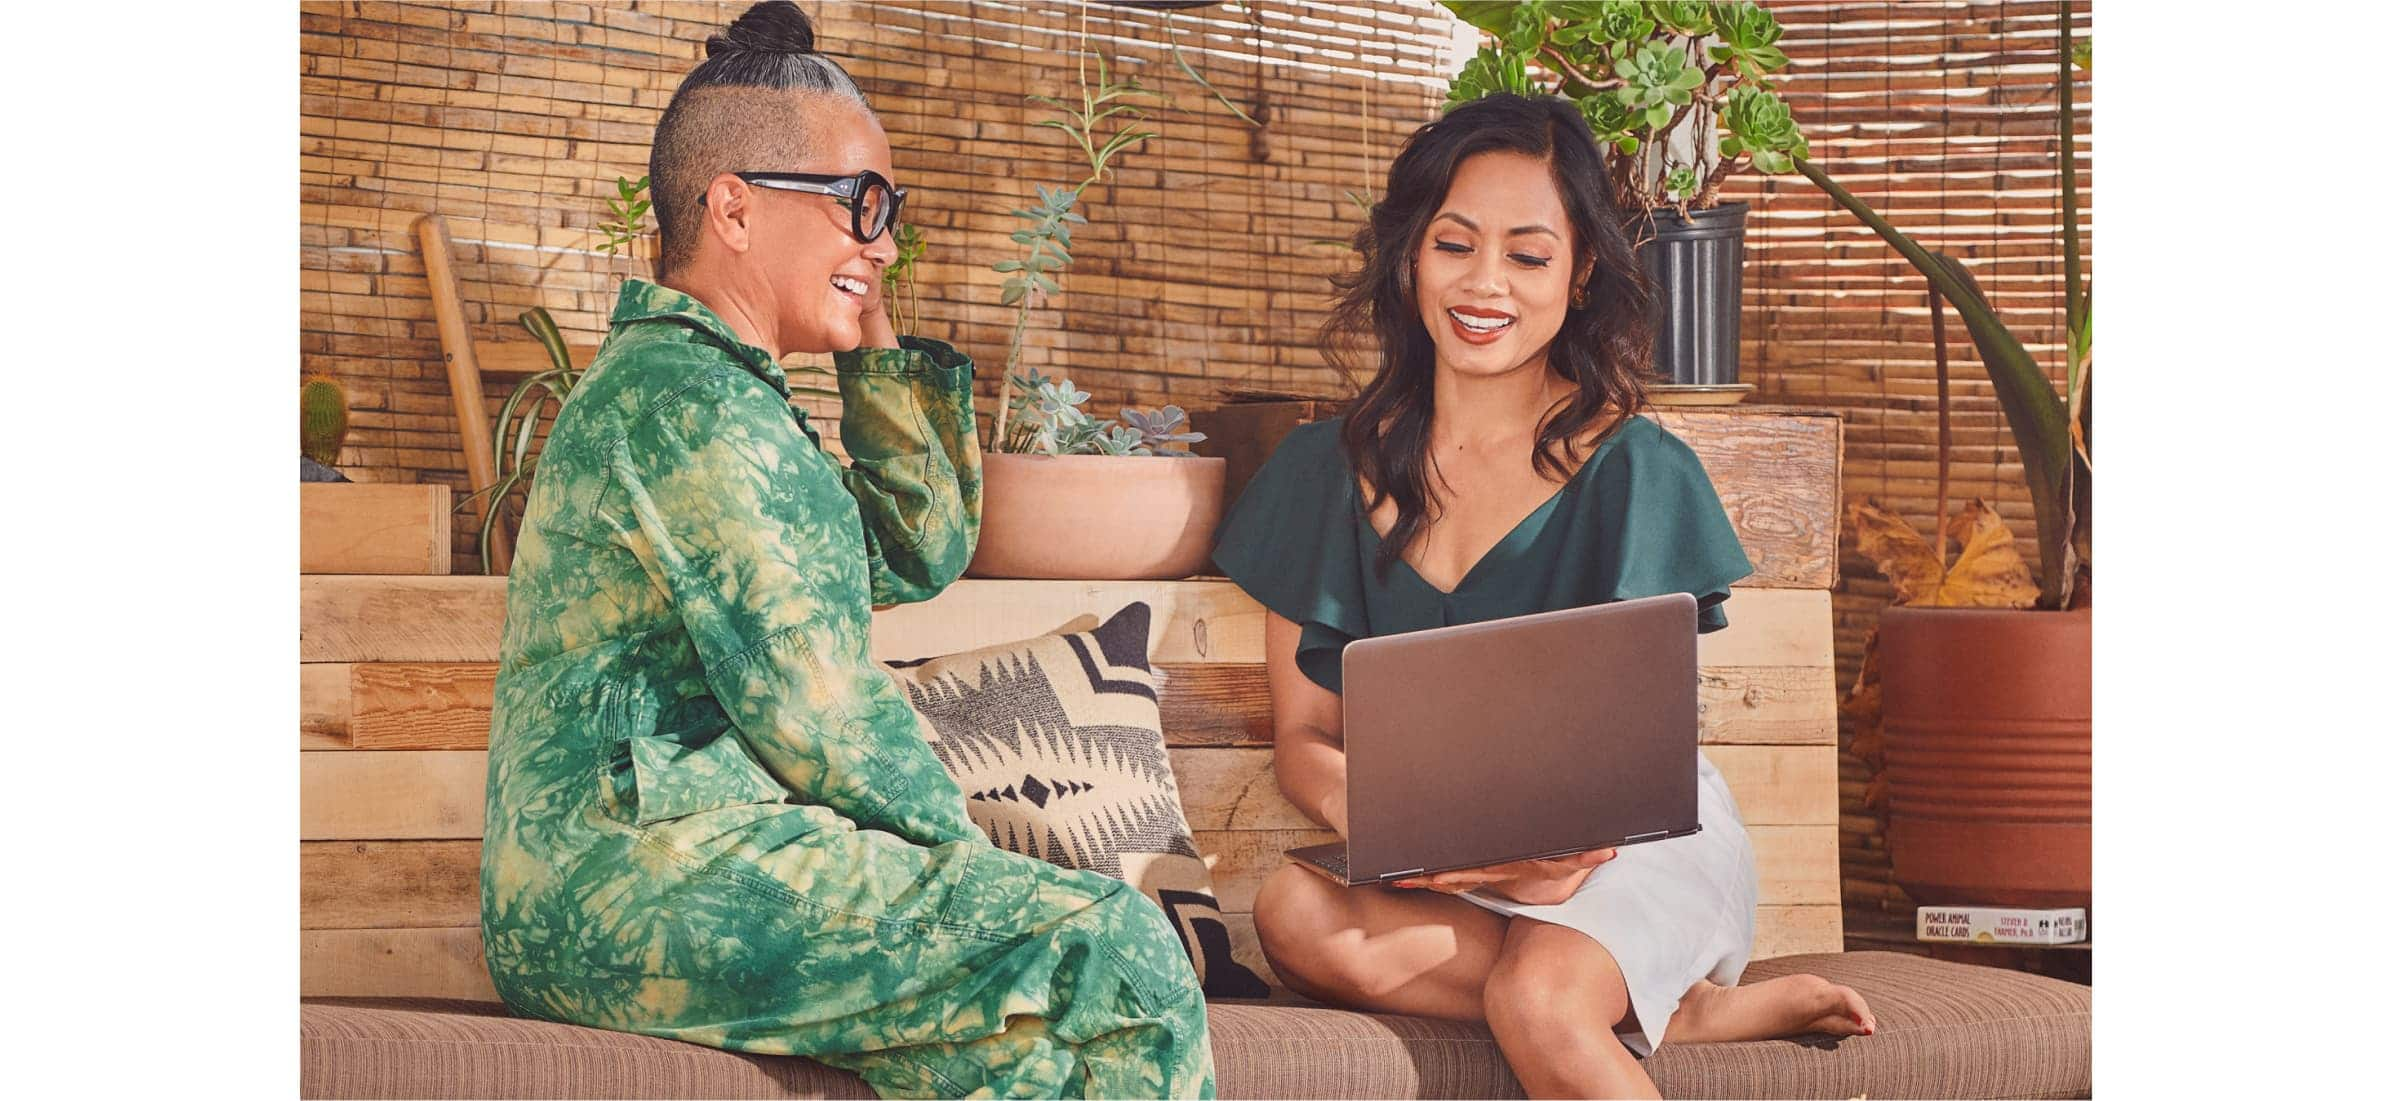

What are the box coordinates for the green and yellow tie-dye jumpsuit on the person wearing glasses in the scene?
[481,280,1213,1096]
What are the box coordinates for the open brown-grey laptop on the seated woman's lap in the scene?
[1287,594,1701,886]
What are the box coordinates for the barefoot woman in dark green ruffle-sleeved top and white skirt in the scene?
[1213,96,1875,1096]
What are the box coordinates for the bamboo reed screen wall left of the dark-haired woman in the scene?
[299,0,1454,548]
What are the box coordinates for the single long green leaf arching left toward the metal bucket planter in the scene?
[1794,158,2076,608]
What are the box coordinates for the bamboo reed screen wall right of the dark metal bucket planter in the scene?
[1727,0,2093,929]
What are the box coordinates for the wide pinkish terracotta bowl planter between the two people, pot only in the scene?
[964,452,1229,582]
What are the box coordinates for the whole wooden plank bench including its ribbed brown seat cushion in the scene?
[299,409,2088,1096]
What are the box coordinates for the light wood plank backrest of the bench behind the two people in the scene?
[299,577,1842,998]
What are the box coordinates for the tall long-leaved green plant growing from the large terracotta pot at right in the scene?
[1794,14,2093,608]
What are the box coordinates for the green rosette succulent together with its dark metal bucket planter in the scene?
[1445,0,1808,402]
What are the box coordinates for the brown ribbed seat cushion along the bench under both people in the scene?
[299,953,2093,1099]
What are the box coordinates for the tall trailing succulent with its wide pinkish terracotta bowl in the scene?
[966,55,1227,579]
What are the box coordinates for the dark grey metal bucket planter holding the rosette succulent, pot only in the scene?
[1643,203,1746,385]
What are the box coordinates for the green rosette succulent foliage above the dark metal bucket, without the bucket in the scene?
[1445,0,1811,213]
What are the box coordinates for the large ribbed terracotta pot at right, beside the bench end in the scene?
[1878,608,2093,907]
